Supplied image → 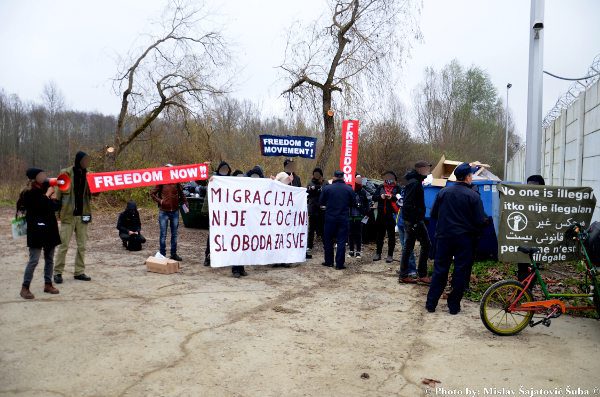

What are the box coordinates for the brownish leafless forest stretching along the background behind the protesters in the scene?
[0,61,519,207]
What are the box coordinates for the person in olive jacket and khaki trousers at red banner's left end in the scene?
[54,151,92,284]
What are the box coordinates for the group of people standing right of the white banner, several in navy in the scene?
[309,161,488,314]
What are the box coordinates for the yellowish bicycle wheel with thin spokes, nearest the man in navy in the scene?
[479,280,533,336]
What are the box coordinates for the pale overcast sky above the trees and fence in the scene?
[0,0,600,139]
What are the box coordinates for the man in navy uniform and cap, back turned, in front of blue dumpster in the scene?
[425,163,487,314]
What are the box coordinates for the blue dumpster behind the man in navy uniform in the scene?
[425,181,500,260]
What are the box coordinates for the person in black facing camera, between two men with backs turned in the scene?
[373,171,400,263]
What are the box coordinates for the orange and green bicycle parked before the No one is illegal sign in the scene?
[479,223,600,336]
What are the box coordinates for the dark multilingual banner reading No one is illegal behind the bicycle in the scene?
[498,184,596,263]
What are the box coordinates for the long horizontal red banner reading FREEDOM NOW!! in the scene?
[87,164,208,193]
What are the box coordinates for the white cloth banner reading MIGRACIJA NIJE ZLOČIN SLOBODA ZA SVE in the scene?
[208,176,308,267]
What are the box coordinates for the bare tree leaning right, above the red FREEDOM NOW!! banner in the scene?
[112,0,229,159]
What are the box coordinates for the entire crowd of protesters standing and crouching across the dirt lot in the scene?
[17,152,488,314]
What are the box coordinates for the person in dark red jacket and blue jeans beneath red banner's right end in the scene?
[150,166,188,261]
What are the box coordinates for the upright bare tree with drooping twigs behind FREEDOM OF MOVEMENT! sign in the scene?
[280,0,420,166]
